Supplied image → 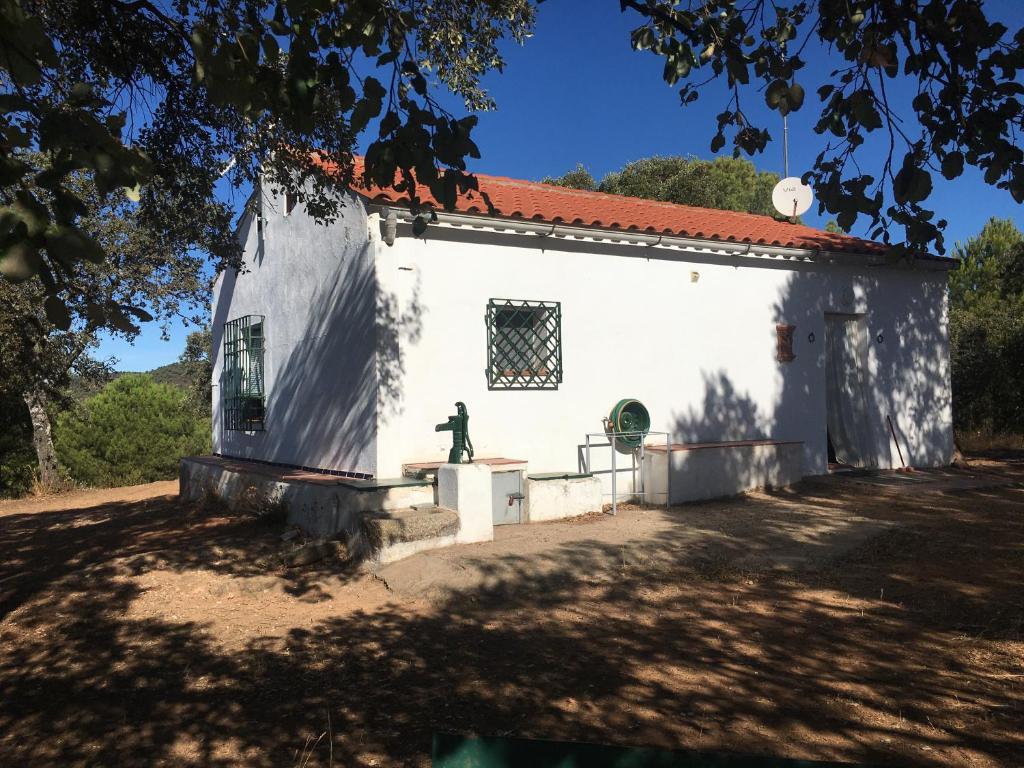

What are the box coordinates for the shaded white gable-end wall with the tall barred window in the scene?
[212,188,378,474]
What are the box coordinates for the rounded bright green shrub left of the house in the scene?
[54,374,210,485]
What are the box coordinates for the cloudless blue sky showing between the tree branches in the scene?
[97,0,1024,371]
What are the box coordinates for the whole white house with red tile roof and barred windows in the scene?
[203,157,952,524]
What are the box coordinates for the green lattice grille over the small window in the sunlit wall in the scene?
[487,299,562,389]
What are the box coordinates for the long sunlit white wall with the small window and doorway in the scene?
[376,219,952,493]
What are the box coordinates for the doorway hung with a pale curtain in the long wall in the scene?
[825,314,876,467]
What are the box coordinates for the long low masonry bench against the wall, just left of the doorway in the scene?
[643,440,804,504]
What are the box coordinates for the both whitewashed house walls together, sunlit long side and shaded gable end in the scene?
[213,195,952,489]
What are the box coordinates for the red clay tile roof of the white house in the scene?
[329,158,886,254]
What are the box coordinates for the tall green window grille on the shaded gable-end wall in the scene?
[220,314,266,432]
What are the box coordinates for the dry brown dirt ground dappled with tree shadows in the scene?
[0,455,1024,768]
